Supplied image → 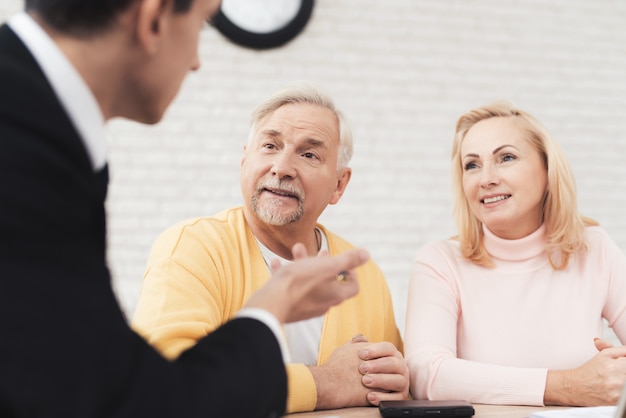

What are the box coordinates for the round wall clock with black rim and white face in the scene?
[212,0,314,49]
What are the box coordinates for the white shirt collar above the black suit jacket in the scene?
[8,12,106,171]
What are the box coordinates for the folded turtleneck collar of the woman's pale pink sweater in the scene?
[483,224,547,261]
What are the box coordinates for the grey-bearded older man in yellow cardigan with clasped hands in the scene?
[133,82,408,412]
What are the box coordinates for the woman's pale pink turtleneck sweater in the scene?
[405,227,626,405]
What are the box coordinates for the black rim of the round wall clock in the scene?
[212,0,314,49]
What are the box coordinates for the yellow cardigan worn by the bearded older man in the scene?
[132,207,402,412]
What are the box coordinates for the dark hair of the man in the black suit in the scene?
[26,0,193,35]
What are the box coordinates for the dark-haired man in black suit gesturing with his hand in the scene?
[0,0,368,418]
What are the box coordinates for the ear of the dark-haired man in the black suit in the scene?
[137,0,172,54]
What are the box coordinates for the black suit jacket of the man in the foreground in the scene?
[0,26,287,418]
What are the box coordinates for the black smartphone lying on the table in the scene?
[378,399,474,418]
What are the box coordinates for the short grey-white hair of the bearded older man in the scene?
[248,81,354,170]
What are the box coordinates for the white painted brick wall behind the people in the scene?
[0,0,626,346]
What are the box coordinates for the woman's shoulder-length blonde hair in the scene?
[452,102,598,270]
